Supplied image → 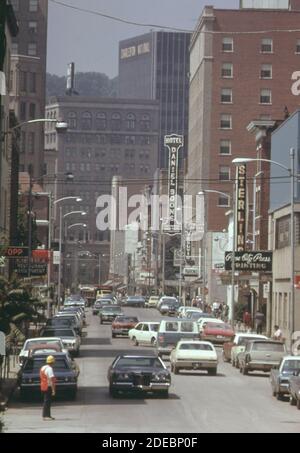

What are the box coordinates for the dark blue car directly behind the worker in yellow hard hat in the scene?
[18,352,79,399]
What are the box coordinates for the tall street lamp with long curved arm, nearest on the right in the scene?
[232,153,297,338]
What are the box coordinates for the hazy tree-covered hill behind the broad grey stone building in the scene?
[47,72,118,99]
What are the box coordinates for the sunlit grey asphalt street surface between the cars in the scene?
[4,309,300,433]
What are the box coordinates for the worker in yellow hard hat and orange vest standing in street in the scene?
[40,355,56,421]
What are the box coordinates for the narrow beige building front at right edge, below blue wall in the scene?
[267,203,300,342]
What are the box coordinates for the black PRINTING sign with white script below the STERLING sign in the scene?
[225,252,273,272]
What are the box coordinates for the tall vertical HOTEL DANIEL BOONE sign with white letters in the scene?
[164,134,184,234]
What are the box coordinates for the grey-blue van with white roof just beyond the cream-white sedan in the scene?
[156,319,199,357]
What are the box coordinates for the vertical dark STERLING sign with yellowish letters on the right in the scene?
[236,165,247,252]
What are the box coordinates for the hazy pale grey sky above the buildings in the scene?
[48,0,239,77]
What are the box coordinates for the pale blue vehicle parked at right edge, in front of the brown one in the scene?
[270,356,300,400]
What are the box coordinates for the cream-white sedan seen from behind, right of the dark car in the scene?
[170,340,218,376]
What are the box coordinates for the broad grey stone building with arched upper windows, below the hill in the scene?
[45,96,159,284]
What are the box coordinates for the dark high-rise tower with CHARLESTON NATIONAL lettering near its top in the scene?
[119,31,191,168]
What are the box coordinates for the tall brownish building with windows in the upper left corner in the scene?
[10,0,48,179]
